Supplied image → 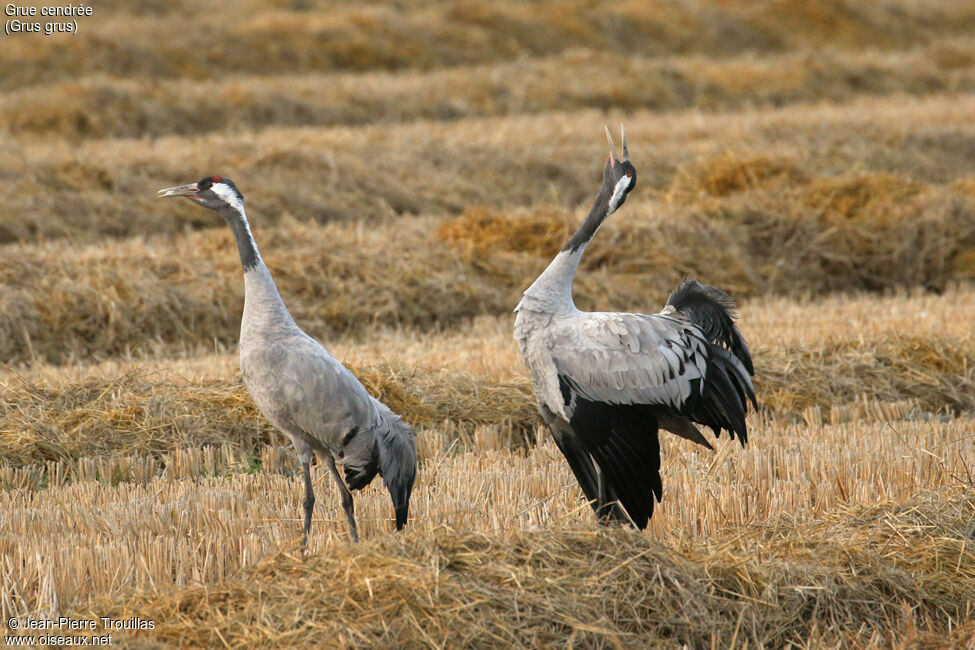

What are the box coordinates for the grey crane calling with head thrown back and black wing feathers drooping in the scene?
[515,126,757,530]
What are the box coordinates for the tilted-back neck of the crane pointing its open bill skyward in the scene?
[515,188,609,313]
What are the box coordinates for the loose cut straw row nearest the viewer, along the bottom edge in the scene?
[82,497,975,647]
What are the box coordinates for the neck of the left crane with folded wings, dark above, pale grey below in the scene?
[220,206,297,336]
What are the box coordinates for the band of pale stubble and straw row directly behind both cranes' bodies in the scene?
[0,288,975,467]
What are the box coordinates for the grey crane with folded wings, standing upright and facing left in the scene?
[158,176,416,543]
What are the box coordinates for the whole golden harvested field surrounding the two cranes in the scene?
[0,0,975,648]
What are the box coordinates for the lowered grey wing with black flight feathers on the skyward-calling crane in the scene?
[536,308,754,529]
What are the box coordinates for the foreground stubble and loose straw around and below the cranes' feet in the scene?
[0,419,975,647]
